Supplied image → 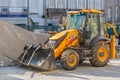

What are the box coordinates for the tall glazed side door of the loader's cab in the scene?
[84,13,100,46]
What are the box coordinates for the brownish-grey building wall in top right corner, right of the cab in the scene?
[104,0,120,24]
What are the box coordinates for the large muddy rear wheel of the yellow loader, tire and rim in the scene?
[90,41,110,67]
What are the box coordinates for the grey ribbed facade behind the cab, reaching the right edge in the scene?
[44,0,120,24]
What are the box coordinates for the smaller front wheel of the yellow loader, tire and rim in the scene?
[60,49,79,70]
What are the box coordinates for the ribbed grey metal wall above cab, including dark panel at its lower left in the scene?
[43,0,104,17]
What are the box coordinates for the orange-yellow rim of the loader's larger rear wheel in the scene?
[98,48,108,62]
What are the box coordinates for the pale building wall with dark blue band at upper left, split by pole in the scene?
[0,0,43,24]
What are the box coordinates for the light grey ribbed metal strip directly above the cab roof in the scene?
[44,0,104,10]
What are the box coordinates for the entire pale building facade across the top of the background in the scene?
[0,0,120,25]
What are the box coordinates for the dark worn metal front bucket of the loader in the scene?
[18,46,56,70]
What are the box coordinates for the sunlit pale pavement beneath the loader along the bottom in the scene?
[0,59,120,80]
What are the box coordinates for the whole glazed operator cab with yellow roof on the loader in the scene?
[67,10,104,47]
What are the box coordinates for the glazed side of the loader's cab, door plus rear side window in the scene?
[83,13,104,46]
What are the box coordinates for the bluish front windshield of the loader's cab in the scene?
[67,13,85,30]
